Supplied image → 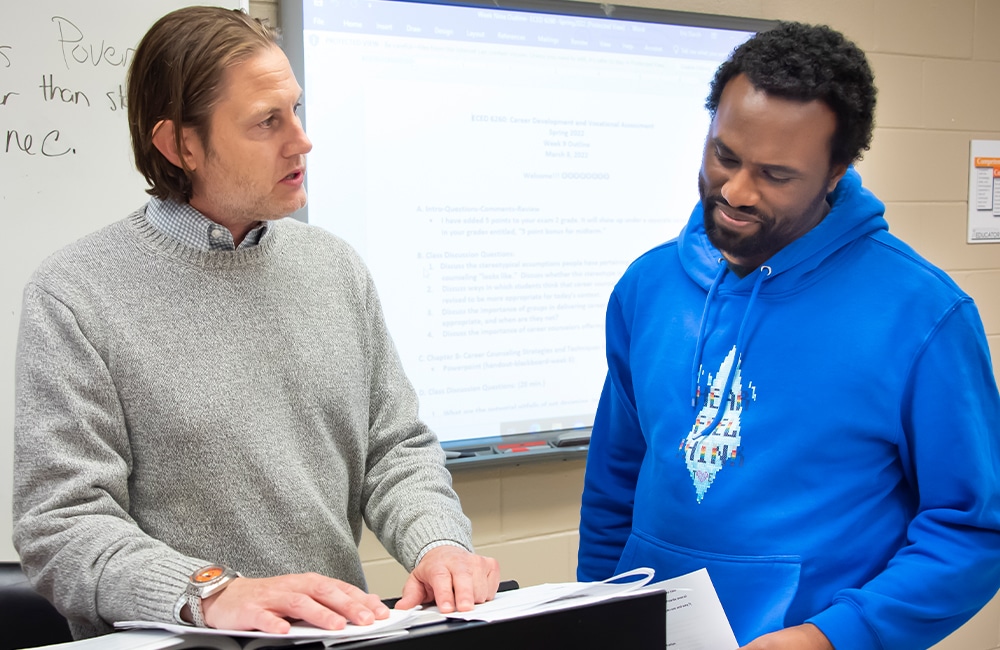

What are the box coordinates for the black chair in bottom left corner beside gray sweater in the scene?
[0,562,73,650]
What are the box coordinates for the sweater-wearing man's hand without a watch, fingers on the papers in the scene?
[396,546,500,614]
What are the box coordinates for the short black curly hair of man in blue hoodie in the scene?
[705,22,876,165]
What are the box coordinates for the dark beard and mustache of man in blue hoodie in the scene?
[698,174,826,266]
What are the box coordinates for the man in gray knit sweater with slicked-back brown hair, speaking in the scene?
[14,7,499,637]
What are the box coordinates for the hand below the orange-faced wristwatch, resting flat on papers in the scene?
[201,576,390,634]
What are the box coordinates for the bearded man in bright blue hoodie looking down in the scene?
[578,24,1000,650]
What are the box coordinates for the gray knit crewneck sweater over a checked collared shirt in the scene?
[14,211,471,637]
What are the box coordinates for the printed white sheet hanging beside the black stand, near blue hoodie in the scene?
[647,569,740,650]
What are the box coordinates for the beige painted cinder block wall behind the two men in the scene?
[250,0,1000,650]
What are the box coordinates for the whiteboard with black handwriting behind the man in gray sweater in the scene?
[0,0,248,561]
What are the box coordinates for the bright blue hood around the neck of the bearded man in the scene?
[678,167,888,293]
